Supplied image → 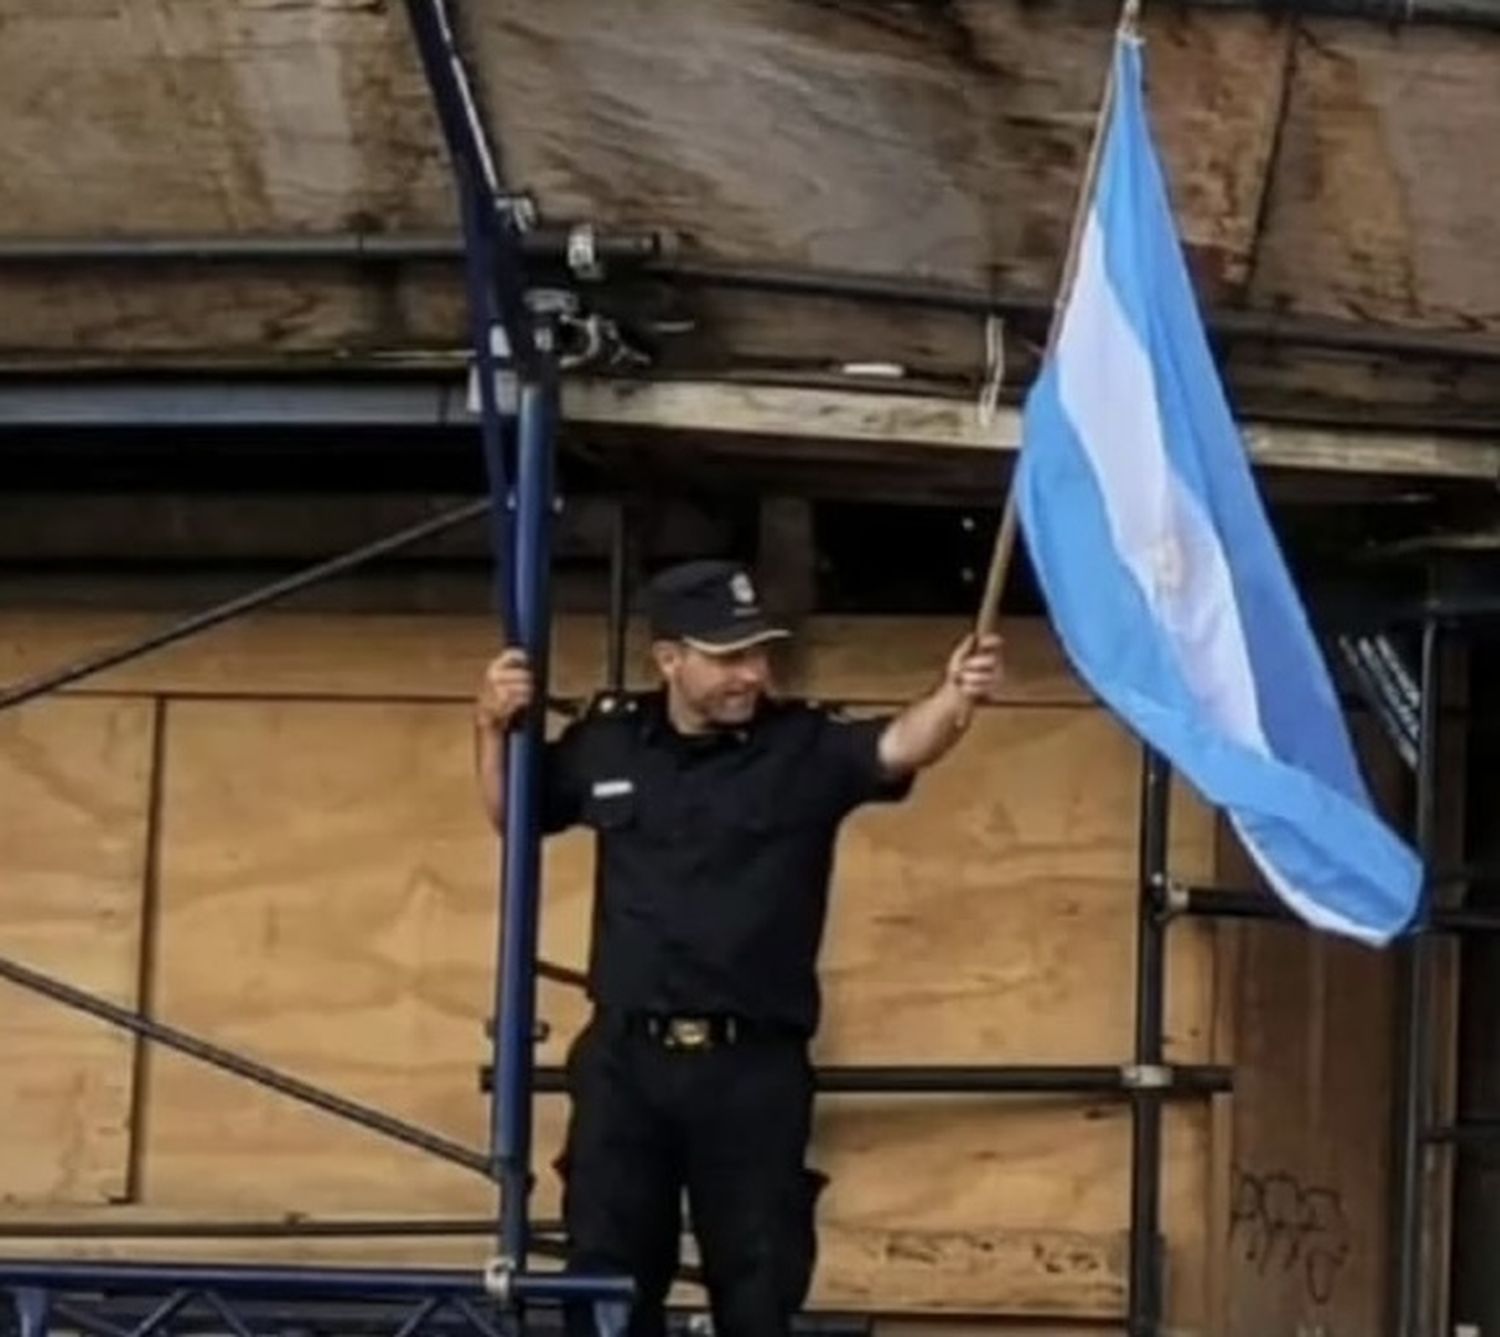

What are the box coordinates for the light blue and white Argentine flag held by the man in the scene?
[1016,35,1422,945]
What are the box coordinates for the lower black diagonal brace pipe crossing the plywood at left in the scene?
[0,956,491,1176]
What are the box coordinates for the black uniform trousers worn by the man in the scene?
[558,1017,825,1337]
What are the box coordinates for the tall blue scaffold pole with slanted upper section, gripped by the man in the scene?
[407,0,632,1334]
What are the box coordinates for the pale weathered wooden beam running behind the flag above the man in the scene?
[563,380,1500,483]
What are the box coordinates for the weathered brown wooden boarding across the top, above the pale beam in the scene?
[0,0,1500,447]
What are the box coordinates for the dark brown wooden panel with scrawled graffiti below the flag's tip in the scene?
[1212,716,1410,1337]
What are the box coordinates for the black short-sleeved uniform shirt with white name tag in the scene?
[542,692,911,1032]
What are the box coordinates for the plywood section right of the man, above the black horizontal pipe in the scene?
[824,707,1214,1062]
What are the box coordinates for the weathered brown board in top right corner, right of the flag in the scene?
[1251,23,1500,329]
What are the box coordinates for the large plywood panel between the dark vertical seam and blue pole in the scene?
[143,704,528,1211]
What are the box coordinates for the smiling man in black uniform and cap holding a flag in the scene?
[477,561,999,1337]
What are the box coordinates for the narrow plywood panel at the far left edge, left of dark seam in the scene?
[0,701,153,1203]
